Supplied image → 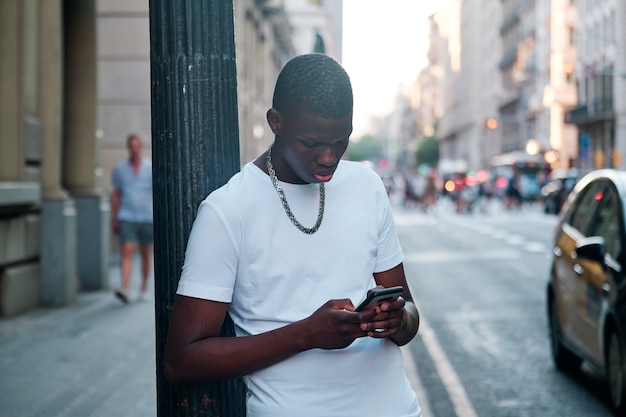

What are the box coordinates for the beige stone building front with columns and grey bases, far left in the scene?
[0,0,109,316]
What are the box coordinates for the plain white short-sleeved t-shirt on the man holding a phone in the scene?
[177,161,420,417]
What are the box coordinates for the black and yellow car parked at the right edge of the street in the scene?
[547,169,626,416]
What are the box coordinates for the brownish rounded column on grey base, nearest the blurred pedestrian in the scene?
[62,0,111,291]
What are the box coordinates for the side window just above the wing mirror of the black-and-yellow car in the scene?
[591,187,622,259]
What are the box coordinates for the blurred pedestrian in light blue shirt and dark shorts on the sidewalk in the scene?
[111,134,153,303]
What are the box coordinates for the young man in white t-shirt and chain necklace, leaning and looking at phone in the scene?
[165,54,420,417]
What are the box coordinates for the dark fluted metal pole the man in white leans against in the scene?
[150,0,245,417]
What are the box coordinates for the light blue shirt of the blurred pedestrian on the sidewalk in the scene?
[111,158,152,223]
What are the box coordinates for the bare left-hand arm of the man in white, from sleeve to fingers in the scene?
[165,295,375,383]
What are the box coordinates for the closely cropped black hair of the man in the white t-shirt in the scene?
[272,53,353,119]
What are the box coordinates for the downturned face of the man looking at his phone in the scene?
[272,111,352,184]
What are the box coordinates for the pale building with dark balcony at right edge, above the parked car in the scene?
[566,0,626,172]
